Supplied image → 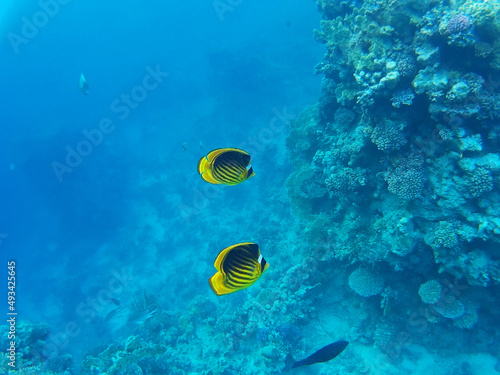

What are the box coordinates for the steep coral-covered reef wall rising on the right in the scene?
[287,0,500,364]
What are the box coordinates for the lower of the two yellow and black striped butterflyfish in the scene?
[208,242,269,296]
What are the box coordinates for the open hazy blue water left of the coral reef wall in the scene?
[0,1,323,374]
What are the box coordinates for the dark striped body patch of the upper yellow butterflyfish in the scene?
[212,151,250,184]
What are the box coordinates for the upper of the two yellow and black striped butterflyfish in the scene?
[198,148,255,185]
